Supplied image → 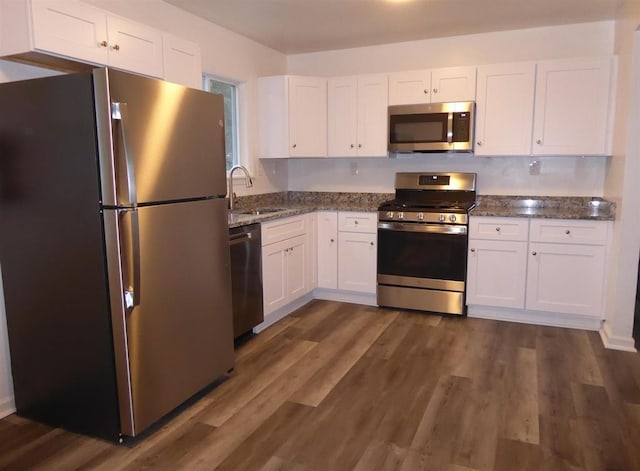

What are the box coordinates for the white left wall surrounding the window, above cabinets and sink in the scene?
[85,0,287,194]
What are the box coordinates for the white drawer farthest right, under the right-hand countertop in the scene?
[529,219,609,245]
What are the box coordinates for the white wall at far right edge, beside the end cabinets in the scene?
[602,0,640,348]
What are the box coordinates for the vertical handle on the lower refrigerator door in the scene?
[119,208,140,312]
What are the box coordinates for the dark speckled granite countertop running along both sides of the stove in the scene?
[229,191,616,227]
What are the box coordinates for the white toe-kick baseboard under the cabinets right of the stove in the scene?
[467,306,602,330]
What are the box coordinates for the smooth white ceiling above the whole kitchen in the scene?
[164,0,623,54]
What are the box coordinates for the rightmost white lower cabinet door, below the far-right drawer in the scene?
[526,242,605,317]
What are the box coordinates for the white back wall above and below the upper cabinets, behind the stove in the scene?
[287,21,615,196]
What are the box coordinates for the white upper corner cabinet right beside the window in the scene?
[258,76,327,158]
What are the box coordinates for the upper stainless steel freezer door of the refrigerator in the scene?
[93,69,226,206]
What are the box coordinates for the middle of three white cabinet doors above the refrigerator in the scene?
[107,16,163,78]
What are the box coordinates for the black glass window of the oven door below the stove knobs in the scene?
[378,229,467,281]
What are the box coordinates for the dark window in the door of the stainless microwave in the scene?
[389,113,449,144]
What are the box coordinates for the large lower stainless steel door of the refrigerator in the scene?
[105,198,233,435]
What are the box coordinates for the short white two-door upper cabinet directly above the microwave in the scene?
[389,67,476,105]
